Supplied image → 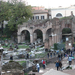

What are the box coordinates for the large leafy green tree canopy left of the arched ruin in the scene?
[0,0,32,41]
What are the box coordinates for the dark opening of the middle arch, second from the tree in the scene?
[33,29,43,42]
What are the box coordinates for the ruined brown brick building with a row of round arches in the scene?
[17,8,75,48]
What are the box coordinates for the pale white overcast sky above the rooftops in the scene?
[26,0,75,8]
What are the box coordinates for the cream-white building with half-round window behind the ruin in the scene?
[51,5,75,18]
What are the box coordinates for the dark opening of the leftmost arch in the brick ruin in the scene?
[21,30,30,43]
